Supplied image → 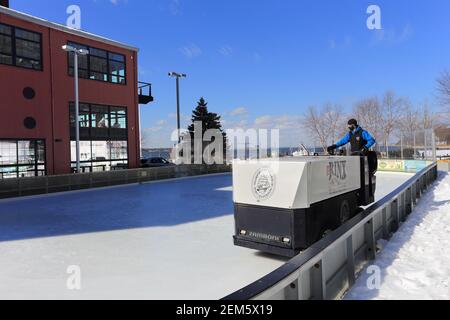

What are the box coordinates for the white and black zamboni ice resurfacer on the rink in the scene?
[233,155,376,257]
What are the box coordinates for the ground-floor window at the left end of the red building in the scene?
[0,140,46,179]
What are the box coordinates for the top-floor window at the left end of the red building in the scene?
[0,24,42,70]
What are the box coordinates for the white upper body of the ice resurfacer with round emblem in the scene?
[233,156,361,209]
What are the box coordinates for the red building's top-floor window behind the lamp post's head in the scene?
[67,42,126,85]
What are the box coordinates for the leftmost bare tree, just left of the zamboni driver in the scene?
[303,103,344,152]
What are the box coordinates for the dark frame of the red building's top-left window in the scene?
[0,22,44,72]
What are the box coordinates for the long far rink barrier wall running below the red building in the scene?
[0,165,231,199]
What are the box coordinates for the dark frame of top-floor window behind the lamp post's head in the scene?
[67,41,128,86]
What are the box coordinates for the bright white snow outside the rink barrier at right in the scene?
[346,173,450,300]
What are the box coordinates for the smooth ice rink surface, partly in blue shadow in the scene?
[0,172,411,299]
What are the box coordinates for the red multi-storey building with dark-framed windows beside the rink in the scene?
[0,0,153,180]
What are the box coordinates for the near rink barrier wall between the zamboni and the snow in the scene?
[223,163,437,300]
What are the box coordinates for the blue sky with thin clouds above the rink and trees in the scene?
[11,0,450,147]
